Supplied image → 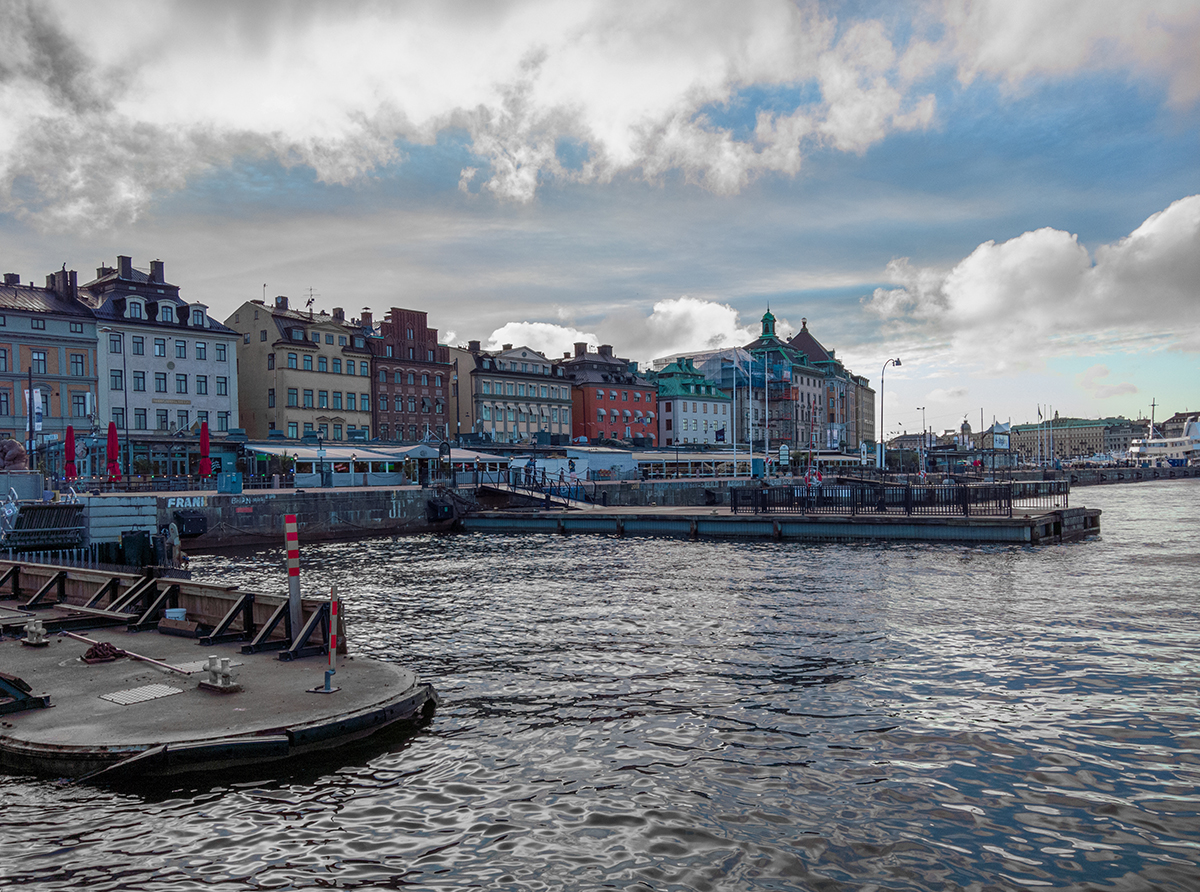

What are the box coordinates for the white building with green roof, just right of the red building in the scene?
[655,357,733,447]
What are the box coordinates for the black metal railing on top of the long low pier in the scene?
[730,480,1070,517]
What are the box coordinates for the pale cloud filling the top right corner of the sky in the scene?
[942,0,1200,106]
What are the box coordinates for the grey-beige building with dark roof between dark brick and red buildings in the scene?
[450,341,574,443]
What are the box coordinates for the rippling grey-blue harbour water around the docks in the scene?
[0,481,1200,891]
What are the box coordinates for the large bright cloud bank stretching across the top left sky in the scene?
[0,0,936,228]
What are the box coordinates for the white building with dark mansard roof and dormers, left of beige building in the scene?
[82,256,238,438]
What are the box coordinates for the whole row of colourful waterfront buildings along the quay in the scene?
[0,256,875,474]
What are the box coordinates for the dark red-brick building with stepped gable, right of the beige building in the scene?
[364,307,457,442]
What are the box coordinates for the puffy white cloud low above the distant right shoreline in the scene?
[866,196,1200,366]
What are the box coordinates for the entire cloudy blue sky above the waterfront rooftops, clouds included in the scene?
[0,0,1200,433]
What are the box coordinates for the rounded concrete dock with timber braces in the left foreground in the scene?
[0,562,437,779]
